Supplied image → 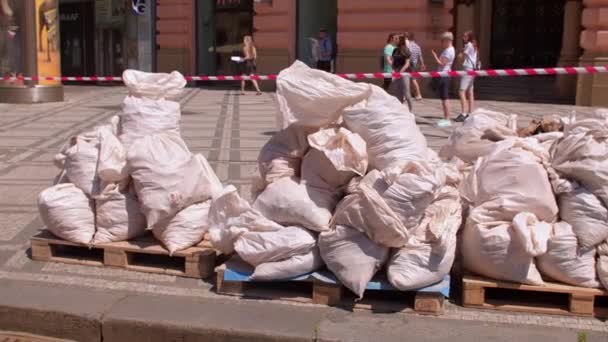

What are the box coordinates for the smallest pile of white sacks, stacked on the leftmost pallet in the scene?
[38,70,222,253]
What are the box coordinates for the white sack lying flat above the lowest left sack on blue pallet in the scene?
[234,227,317,267]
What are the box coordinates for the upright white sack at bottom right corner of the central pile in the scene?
[387,187,462,291]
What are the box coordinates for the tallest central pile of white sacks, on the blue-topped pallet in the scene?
[209,62,462,297]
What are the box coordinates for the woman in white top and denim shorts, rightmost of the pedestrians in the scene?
[454,31,480,122]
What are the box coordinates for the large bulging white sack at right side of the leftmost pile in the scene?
[127,132,222,228]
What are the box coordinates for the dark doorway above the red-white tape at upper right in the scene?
[490,0,565,69]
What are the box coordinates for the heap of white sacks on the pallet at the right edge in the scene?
[441,110,608,288]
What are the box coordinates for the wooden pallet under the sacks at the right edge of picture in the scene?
[462,275,608,317]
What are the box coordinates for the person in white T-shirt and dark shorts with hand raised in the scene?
[432,32,456,127]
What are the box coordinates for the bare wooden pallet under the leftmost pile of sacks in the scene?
[30,230,217,278]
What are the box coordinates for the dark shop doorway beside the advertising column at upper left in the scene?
[59,2,95,76]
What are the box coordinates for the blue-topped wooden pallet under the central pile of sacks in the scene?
[216,258,450,315]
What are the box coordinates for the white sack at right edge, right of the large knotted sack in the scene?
[557,186,608,248]
